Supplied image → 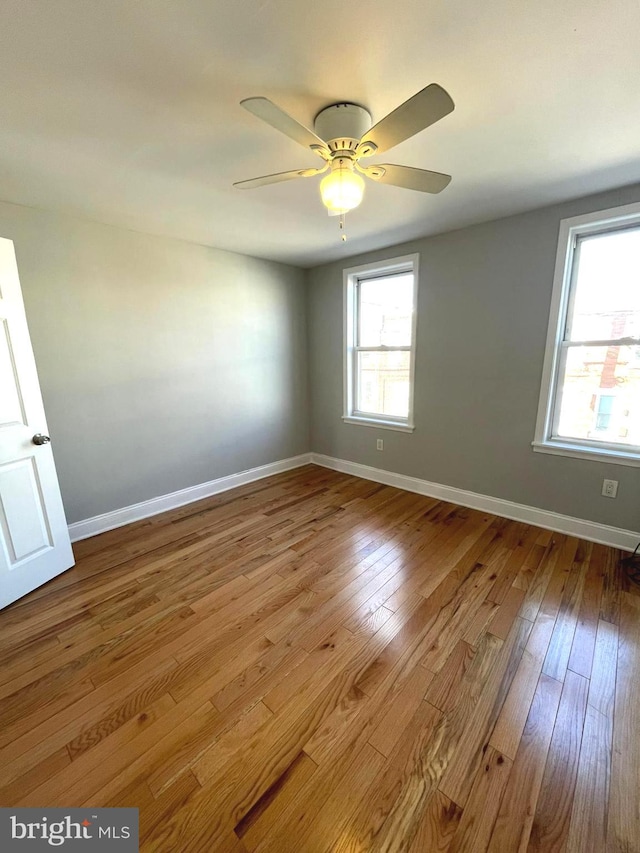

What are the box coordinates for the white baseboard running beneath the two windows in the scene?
[311,453,640,551]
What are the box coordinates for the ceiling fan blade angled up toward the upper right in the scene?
[358,83,455,157]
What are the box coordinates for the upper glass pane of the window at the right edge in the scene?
[568,228,640,341]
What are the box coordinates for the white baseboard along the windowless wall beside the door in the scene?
[69,453,311,542]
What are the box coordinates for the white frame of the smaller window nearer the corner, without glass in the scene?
[342,253,419,432]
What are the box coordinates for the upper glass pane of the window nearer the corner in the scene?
[358,273,413,347]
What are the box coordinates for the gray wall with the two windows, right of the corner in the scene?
[308,186,640,530]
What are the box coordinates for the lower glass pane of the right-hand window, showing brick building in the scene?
[558,346,640,445]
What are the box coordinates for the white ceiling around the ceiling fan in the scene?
[0,0,640,266]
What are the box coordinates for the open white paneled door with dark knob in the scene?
[0,238,74,607]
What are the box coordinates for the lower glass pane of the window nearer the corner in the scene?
[357,352,410,418]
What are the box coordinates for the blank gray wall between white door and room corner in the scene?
[0,204,309,522]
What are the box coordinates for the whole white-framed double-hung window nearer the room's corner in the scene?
[344,255,418,432]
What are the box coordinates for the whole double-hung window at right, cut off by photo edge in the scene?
[533,205,640,465]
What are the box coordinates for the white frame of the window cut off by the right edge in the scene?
[532,204,640,467]
